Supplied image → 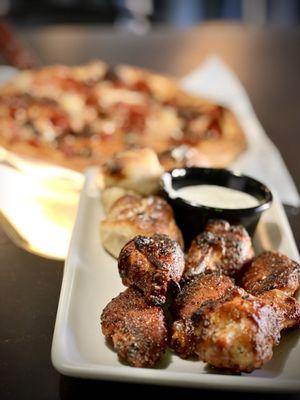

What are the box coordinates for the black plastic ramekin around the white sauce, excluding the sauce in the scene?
[161,167,273,246]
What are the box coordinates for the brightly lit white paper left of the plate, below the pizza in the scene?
[0,165,83,260]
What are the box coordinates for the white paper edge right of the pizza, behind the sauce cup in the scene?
[181,57,300,207]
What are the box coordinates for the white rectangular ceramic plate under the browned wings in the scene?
[52,169,300,391]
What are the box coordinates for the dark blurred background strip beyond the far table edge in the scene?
[0,0,300,27]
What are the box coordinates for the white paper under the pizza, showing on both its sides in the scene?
[0,57,300,259]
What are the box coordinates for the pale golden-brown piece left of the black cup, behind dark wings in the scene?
[100,194,183,258]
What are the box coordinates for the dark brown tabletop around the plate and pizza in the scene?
[0,23,300,399]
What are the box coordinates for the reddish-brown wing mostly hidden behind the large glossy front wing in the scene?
[171,273,234,358]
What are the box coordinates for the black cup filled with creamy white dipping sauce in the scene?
[161,167,273,245]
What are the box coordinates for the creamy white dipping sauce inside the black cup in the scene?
[172,185,259,209]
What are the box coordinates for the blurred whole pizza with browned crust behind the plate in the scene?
[0,61,246,171]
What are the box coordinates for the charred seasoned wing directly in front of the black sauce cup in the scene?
[184,220,254,278]
